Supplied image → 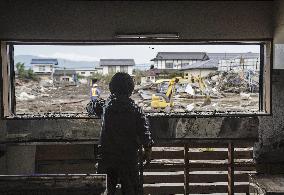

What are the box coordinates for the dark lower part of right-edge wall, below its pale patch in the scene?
[254,70,284,173]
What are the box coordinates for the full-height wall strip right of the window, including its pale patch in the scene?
[254,1,284,173]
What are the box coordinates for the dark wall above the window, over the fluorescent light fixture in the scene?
[0,0,273,40]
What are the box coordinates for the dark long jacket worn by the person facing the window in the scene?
[96,95,153,164]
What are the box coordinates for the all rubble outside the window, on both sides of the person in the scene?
[15,69,259,113]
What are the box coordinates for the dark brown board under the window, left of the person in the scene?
[36,144,95,161]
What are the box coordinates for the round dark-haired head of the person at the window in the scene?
[109,72,134,97]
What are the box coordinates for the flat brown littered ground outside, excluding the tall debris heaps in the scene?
[16,80,259,114]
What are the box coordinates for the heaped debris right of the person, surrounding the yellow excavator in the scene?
[137,71,259,112]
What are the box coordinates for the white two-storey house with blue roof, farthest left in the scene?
[31,58,58,80]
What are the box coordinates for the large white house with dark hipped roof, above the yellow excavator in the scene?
[151,52,209,69]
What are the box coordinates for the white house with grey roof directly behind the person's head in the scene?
[100,59,135,75]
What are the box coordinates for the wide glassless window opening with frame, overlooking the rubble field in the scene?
[2,42,271,117]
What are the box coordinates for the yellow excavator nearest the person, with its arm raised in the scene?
[151,77,179,109]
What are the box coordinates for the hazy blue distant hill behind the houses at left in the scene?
[14,55,99,68]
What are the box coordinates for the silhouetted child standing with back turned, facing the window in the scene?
[95,72,153,195]
